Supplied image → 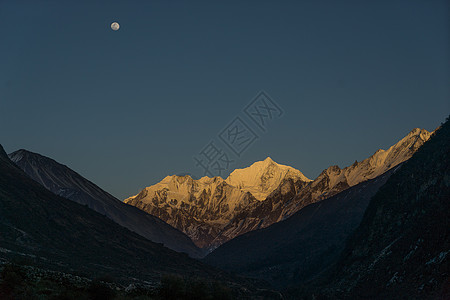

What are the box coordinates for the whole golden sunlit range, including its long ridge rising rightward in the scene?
[125,128,431,250]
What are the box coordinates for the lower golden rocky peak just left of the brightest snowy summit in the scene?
[125,176,257,247]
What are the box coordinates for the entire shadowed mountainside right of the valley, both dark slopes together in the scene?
[204,121,450,299]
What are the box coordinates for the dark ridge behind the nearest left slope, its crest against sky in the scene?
[9,150,202,258]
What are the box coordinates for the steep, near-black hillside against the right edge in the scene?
[298,120,450,299]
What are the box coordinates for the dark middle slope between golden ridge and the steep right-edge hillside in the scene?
[204,167,398,288]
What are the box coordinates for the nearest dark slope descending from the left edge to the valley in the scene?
[0,146,230,288]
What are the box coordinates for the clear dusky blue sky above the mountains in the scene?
[0,0,450,199]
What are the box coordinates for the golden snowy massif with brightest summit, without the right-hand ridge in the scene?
[125,158,310,248]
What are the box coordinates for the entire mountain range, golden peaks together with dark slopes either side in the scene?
[0,121,450,299]
